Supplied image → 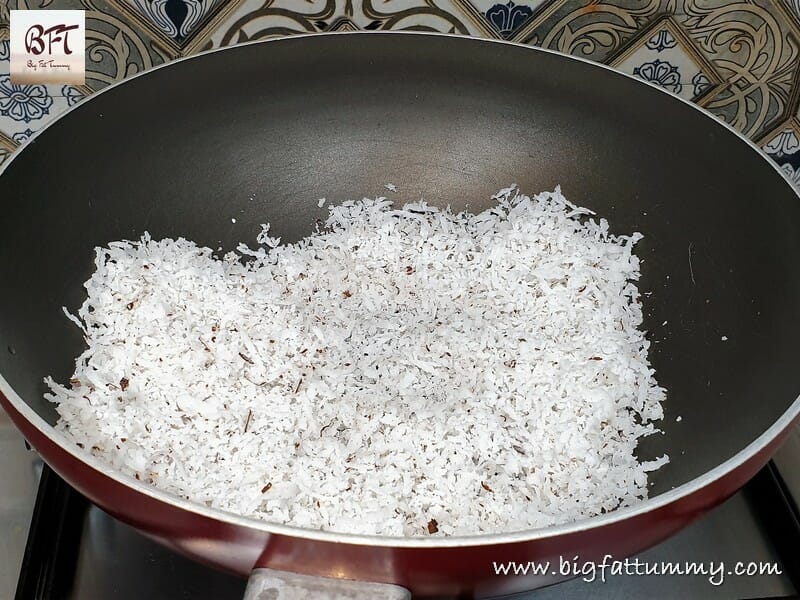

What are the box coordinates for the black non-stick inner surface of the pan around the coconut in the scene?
[0,34,800,492]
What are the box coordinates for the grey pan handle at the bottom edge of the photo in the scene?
[244,568,411,600]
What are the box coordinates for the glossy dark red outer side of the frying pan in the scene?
[0,393,792,598]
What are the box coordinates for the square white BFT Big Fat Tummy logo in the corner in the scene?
[10,10,86,85]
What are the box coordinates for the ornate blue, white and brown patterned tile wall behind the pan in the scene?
[0,0,800,186]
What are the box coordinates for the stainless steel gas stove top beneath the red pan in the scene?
[0,422,800,600]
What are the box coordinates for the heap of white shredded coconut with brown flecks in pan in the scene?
[46,188,667,536]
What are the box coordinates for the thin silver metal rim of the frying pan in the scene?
[0,31,800,549]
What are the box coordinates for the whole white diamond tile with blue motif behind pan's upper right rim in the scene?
[612,22,719,100]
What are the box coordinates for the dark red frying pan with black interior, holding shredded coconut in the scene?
[0,33,800,598]
